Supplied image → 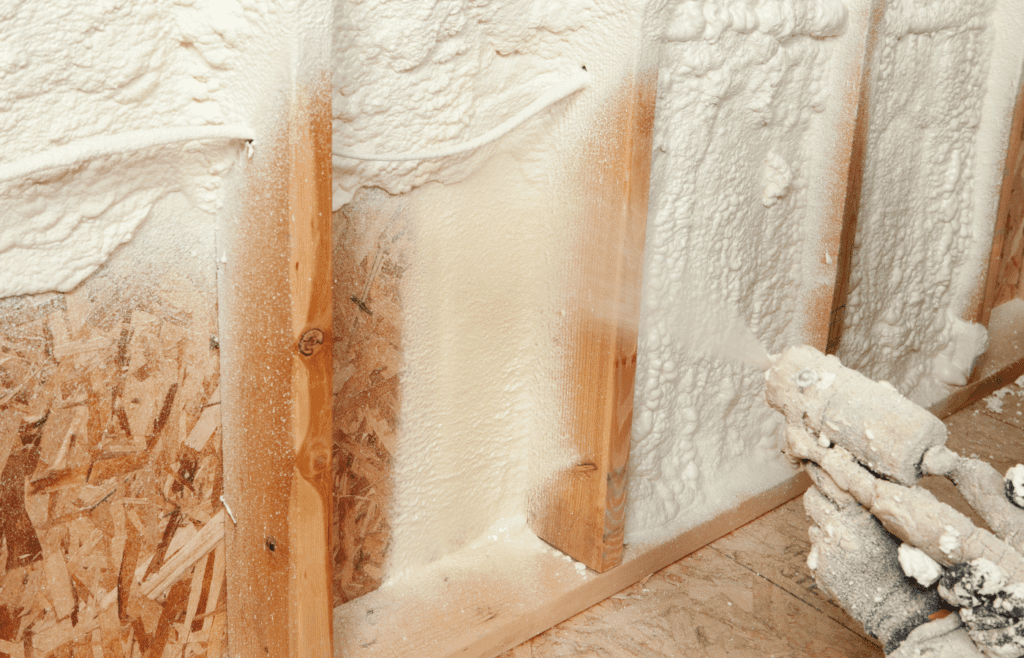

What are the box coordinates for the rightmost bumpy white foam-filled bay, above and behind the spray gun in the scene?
[840,0,1024,405]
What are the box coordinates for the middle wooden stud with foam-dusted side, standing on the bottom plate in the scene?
[529,72,657,572]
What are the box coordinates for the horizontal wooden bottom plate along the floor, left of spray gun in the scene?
[334,476,808,658]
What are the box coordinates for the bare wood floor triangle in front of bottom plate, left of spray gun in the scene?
[500,540,883,658]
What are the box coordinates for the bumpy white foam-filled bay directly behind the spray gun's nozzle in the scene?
[627,0,867,541]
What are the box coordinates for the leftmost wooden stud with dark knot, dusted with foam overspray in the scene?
[221,76,333,658]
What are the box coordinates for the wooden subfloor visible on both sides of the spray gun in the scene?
[501,385,1024,658]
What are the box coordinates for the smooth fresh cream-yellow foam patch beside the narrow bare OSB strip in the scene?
[387,149,571,580]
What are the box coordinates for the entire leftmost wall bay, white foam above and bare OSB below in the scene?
[0,0,330,657]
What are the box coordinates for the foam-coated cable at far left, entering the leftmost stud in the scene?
[0,126,256,181]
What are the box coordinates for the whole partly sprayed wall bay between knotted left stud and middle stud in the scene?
[334,1,659,591]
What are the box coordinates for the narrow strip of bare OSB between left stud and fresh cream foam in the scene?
[333,190,409,606]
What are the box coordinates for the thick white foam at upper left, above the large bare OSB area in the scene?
[0,0,311,297]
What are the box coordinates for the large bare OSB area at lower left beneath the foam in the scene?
[0,277,225,658]
